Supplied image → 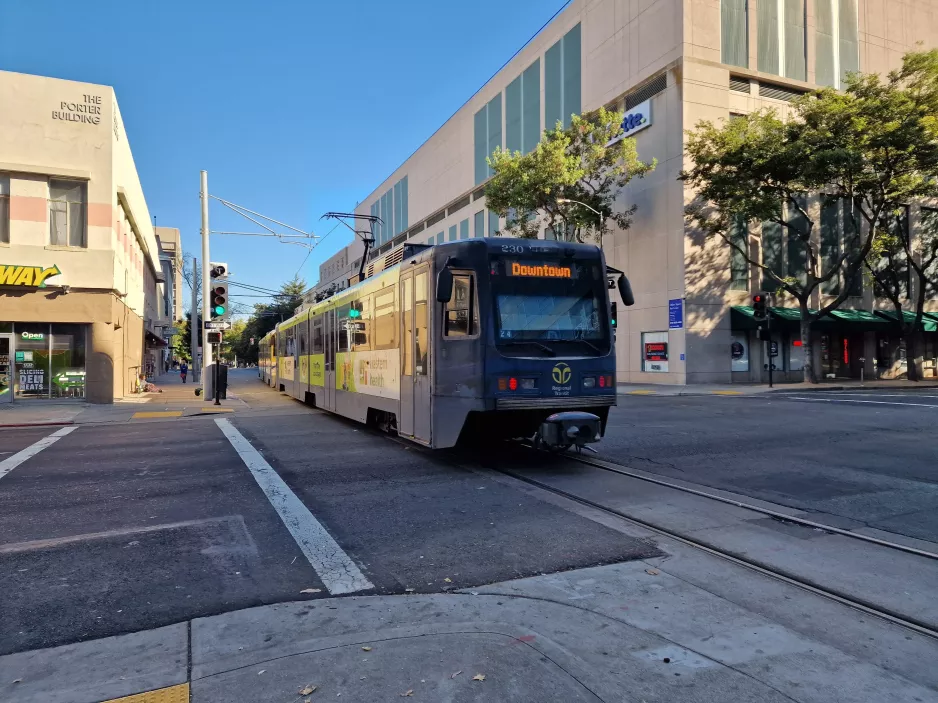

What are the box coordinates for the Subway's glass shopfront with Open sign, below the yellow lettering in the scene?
[0,322,88,403]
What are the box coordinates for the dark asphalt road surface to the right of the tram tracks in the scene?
[597,389,938,542]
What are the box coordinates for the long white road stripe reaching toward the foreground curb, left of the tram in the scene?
[215,418,374,594]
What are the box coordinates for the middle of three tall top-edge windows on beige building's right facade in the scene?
[758,0,807,81]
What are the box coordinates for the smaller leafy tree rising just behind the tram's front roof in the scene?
[485,108,657,242]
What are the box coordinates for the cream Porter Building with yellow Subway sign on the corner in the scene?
[0,71,171,403]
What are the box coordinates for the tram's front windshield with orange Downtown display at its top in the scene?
[493,261,609,356]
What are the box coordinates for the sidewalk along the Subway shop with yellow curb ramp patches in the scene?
[0,371,246,428]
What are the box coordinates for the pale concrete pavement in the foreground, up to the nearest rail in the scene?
[0,546,938,703]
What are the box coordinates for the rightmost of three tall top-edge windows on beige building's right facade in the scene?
[814,0,860,88]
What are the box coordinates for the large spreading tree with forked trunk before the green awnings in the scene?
[680,52,938,383]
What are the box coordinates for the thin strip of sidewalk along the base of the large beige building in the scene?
[617,378,938,396]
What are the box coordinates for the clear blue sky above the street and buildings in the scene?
[0,0,563,310]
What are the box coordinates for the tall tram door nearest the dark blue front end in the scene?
[398,266,430,442]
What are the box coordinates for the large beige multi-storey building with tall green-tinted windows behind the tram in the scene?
[332,0,938,384]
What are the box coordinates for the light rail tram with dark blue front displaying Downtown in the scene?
[258,238,634,449]
